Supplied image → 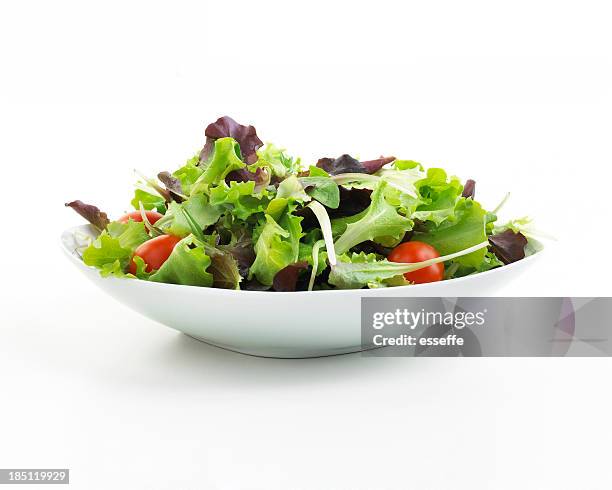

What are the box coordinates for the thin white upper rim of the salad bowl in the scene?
[60,225,548,296]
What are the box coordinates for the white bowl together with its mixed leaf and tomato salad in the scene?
[62,116,542,357]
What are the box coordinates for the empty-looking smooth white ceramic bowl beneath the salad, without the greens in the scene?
[61,225,541,358]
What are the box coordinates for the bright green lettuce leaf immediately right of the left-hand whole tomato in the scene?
[149,236,213,287]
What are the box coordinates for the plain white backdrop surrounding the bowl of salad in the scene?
[0,0,612,490]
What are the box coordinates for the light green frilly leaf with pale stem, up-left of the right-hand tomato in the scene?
[335,180,413,255]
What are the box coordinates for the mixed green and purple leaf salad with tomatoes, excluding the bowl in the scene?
[66,117,530,291]
